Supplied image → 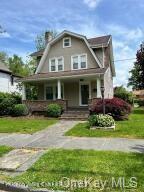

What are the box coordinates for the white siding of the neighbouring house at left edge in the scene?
[0,72,20,93]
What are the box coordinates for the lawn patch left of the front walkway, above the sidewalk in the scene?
[0,118,58,134]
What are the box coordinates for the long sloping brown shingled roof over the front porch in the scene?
[18,68,107,82]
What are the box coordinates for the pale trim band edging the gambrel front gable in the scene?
[36,30,102,73]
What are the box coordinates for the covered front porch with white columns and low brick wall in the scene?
[22,75,104,111]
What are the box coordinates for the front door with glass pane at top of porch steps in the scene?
[80,84,89,106]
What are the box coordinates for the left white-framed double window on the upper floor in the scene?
[49,57,64,72]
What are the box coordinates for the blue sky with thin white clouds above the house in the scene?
[0,0,144,85]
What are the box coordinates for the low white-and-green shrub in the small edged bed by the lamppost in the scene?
[88,114,115,127]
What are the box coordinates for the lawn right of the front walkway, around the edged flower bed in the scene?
[65,108,144,138]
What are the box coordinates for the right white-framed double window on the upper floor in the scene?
[71,54,87,70]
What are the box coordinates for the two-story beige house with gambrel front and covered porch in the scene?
[21,30,115,114]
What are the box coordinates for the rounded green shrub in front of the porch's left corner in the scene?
[12,104,28,116]
